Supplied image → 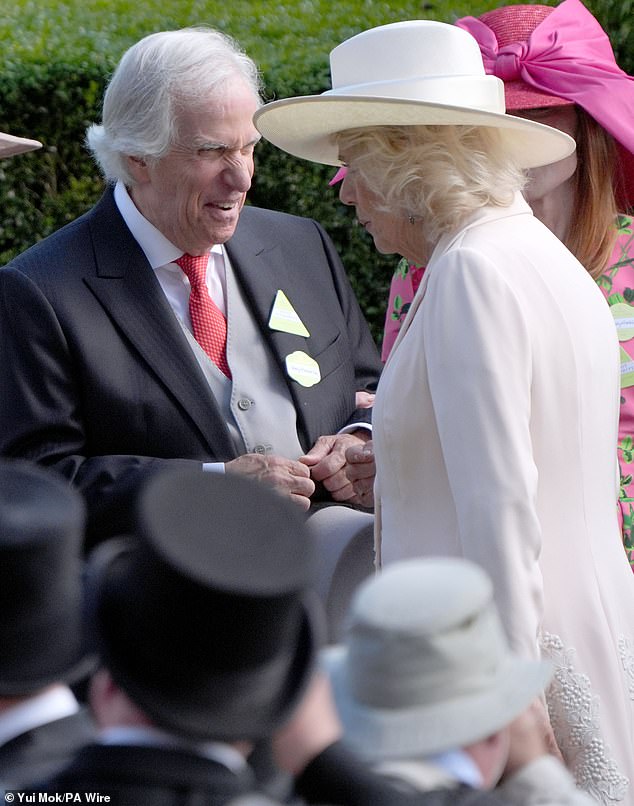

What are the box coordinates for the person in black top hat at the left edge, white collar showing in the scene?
[0,460,93,791]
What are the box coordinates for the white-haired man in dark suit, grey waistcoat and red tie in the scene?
[0,28,380,636]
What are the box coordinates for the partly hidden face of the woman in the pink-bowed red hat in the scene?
[513,104,577,204]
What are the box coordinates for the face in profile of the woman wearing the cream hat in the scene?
[339,163,422,262]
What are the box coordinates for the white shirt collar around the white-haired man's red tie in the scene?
[114,182,228,318]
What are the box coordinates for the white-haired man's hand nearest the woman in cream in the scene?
[299,428,371,507]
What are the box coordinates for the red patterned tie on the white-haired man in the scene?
[174,254,231,378]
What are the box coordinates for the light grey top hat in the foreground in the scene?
[323,557,552,761]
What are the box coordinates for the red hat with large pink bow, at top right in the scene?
[456,0,634,208]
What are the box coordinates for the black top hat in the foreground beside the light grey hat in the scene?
[88,468,316,741]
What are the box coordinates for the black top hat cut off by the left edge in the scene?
[0,460,89,697]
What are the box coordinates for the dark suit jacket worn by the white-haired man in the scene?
[0,189,380,539]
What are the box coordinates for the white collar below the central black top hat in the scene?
[99,725,247,773]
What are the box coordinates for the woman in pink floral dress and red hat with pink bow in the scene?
[456,0,634,570]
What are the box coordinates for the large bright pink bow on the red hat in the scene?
[456,0,634,158]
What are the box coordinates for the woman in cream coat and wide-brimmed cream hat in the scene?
[256,20,634,803]
